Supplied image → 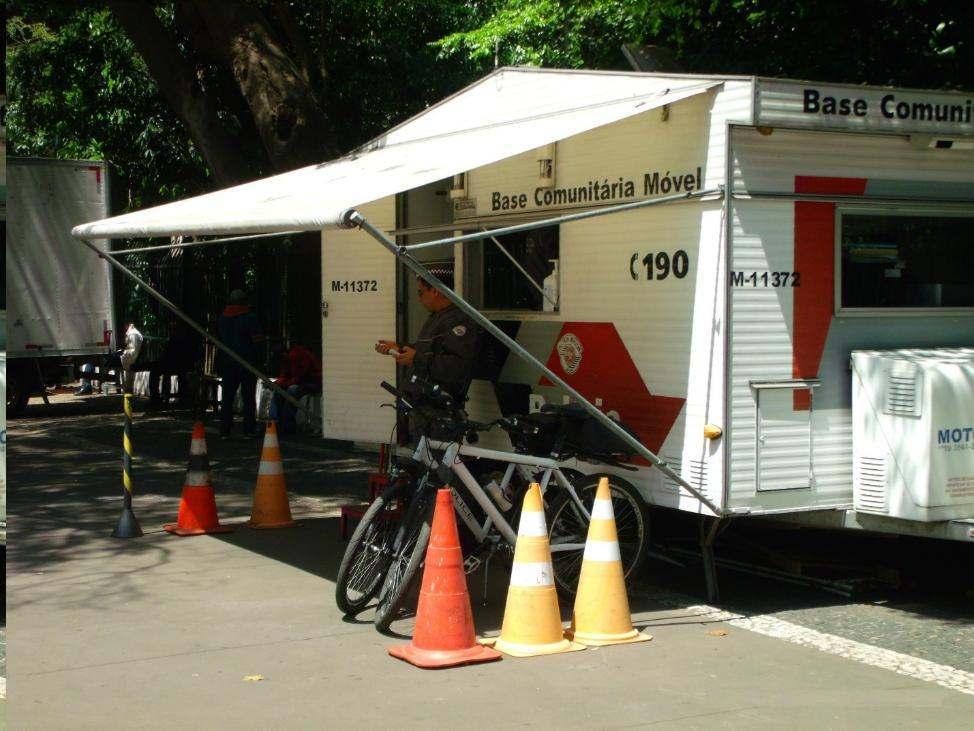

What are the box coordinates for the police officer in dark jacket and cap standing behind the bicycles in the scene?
[375,264,480,405]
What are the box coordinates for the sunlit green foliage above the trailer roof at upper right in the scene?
[437,0,974,89]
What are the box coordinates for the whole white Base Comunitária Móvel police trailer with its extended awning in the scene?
[75,69,974,540]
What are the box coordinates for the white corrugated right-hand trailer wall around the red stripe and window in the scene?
[729,128,974,511]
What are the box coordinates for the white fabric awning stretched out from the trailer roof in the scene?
[72,69,720,239]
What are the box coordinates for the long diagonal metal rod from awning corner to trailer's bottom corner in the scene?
[341,209,723,516]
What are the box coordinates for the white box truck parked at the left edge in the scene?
[6,158,115,416]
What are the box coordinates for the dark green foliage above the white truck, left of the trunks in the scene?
[7,7,207,210]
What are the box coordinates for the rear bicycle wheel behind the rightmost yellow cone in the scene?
[548,475,649,594]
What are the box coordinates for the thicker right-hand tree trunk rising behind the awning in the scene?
[194,0,337,171]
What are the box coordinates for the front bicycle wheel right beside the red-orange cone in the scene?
[374,479,436,632]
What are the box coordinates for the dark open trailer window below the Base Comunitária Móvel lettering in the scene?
[465,226,559,312]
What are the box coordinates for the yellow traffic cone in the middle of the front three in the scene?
[488,483,585,657]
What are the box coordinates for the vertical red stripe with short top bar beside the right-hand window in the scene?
[792,175,866,411]
